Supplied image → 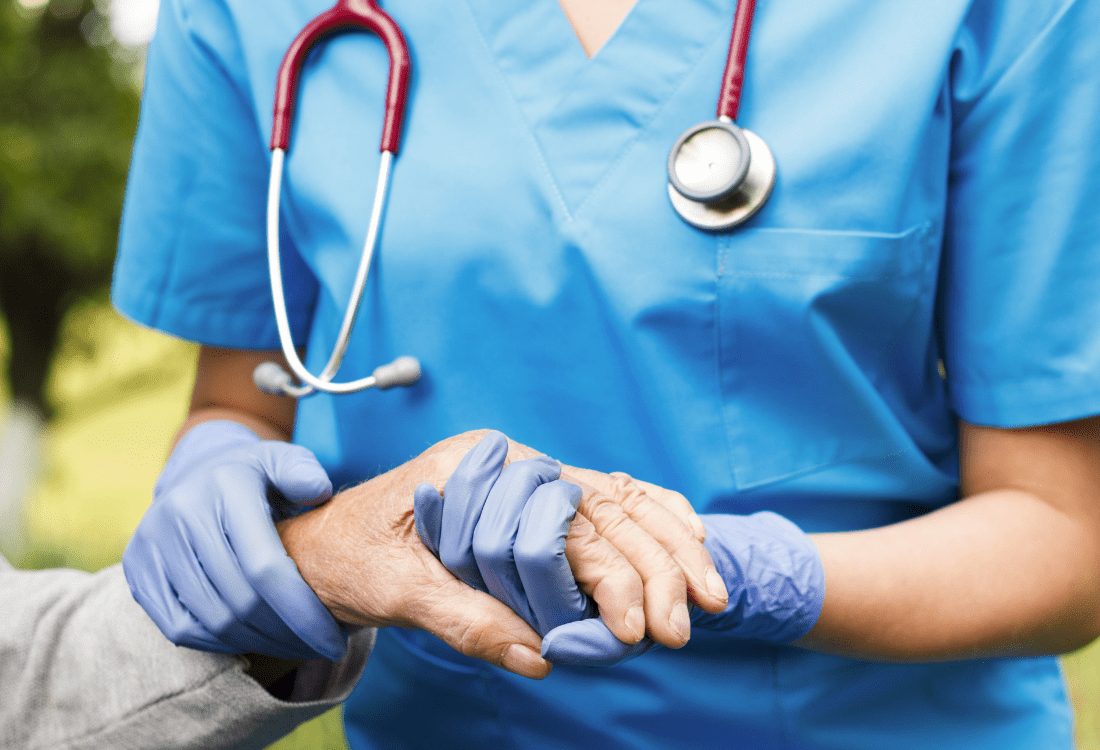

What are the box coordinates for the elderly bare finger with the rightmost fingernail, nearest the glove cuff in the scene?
[611,472,729,613]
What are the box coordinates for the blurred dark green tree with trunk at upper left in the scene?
[0,0,139,411]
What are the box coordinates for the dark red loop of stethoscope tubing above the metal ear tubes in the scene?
[271,0,413,154]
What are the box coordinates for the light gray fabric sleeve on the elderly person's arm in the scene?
[0,558,374,750]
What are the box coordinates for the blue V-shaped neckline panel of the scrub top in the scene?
[466,0,735,217]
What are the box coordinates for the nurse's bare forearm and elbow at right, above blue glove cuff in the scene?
[798,420,1100,661]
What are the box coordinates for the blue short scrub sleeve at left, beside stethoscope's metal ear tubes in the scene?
[112,0,317,349]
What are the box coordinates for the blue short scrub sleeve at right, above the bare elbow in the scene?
[939,0,1100,427]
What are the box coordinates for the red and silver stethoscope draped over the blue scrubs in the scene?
[252,0,776,398]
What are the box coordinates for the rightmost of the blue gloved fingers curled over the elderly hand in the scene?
[514,479,589,635]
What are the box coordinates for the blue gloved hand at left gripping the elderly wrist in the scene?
[122,421,347,661]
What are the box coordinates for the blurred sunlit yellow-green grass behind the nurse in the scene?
[0,304,1100,750]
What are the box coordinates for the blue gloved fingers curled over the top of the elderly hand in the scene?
[414,432,653,663]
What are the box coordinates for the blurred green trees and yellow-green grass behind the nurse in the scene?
[0,0,1100,750]
